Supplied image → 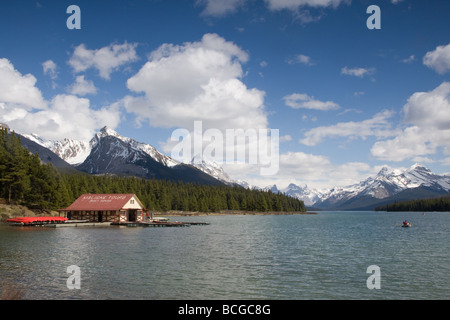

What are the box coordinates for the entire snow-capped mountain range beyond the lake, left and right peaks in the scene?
[18,127,450,210]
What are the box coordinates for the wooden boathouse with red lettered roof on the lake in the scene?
[59,194,147,223]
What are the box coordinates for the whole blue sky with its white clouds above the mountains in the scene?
[0,0,450,188]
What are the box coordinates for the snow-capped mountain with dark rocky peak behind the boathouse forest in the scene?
[24,127,230,184]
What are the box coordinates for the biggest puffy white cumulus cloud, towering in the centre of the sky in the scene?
[123,34,268,130]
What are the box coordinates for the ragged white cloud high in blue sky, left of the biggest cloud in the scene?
[69,42,138,80]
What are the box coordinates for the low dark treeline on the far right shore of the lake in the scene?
[375,196,450,211]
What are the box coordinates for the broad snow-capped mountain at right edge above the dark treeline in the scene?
[314,164,450,209]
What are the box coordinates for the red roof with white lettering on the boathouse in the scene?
[61,194,144,211]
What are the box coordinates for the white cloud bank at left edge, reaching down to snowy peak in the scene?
[0,59,120,140]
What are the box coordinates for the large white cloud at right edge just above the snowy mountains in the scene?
[371,82,450,161]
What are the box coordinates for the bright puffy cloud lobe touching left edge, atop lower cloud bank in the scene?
[0,58,46,111]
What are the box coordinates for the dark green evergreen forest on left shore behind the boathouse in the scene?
[0,130,306,212]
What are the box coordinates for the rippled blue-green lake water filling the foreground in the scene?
[0,212,450,300]
